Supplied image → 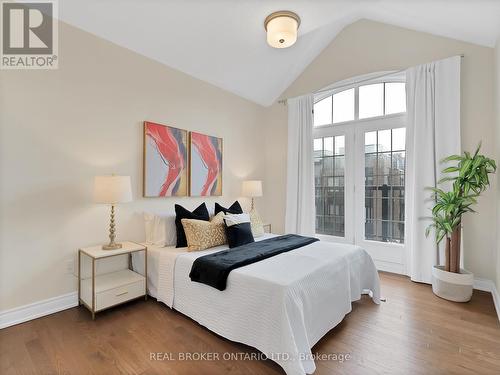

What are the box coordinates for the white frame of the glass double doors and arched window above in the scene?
[313,73,409,274]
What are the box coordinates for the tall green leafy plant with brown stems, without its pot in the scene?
[425,144,497,273]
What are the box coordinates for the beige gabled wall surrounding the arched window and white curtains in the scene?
[266,20,498,280]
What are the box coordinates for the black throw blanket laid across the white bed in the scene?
[189,234,318,290]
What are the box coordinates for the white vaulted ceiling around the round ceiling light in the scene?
[59,0,500,105]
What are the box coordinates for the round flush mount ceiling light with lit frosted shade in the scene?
[264,10,300,48]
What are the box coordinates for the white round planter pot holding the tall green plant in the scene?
[432,266,474,302]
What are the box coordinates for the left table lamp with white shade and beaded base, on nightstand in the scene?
[94,175,132,250]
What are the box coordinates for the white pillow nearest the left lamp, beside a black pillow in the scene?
[144,212,177,247]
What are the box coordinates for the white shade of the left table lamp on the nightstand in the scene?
[94,176,132,204]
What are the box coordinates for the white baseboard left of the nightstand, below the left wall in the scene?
[0,292,78,329]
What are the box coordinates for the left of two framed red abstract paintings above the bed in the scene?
[143,121,189,197]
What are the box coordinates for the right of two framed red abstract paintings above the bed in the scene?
[189,132,222,197]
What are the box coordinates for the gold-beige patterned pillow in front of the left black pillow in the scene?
[181,212,227,251]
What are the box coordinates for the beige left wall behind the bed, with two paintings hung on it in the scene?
[0,24,265,311]
